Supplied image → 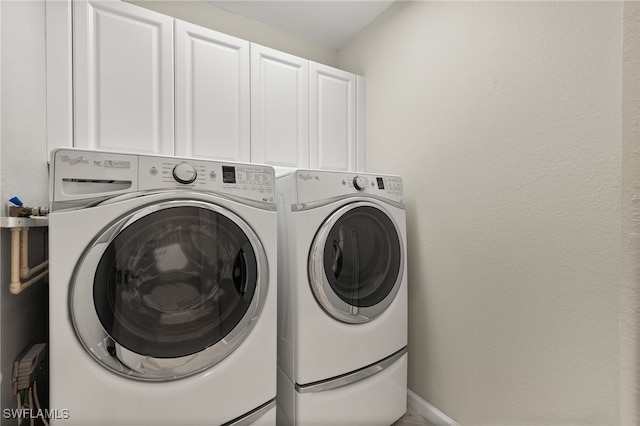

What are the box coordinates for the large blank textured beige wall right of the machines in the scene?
[338,1,639,425]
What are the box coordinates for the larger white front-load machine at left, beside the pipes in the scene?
[49,149,277,426]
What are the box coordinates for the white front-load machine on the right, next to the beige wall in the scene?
[276,170,408,426]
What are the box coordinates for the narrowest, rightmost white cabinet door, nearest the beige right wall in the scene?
[309,62,357,171]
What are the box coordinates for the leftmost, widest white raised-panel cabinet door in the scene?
[73,0,173,154]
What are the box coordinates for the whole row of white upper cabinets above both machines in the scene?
[50,0,365,171]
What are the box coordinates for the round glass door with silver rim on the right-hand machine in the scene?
[309,202,403,323]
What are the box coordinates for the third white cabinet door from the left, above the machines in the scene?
[251,44,309,167]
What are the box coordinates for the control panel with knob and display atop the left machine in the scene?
[49,148,275,203]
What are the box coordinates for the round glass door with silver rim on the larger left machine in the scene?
[71,201,267,380]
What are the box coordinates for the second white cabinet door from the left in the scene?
[175,20,251,161]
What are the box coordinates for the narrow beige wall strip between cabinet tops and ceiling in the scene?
[126,0,336,66]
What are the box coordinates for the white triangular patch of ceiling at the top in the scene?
[209,0,394,49]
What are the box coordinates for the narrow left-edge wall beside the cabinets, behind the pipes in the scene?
[0,1,48,416]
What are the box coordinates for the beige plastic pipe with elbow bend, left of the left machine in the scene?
[9,227,49,294]
